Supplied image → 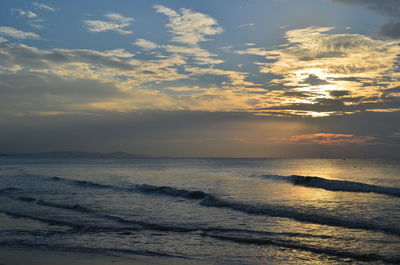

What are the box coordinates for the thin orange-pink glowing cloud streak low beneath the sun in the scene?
[288,133,375,145]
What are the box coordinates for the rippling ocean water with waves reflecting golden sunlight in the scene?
[0,158,400,265]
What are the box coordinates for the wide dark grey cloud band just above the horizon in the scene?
[0,111,400,157]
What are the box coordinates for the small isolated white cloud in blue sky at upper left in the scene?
[83,13,134,34]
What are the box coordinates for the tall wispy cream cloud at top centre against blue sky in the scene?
[154,5,223,45]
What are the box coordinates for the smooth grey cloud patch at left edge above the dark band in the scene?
[0,72,123,113]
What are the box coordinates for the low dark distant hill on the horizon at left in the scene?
[0,151,149,158]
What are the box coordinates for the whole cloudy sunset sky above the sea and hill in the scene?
[0,0,400,158]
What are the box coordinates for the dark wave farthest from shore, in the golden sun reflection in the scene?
[260,175,400,197]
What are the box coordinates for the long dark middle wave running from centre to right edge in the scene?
[137,186,400,235]
